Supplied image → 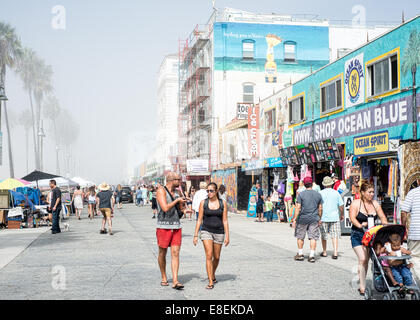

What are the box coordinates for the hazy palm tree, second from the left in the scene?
[18,48,40,170]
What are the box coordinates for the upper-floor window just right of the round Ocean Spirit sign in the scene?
[367,54,398,97]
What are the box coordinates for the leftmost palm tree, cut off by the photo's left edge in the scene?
[0,22,22,178]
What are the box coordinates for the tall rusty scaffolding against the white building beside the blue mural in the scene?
[175,24,212,173]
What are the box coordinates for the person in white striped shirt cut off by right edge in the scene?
[401,178,420,279]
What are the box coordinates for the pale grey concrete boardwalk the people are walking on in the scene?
[0,204,374,300]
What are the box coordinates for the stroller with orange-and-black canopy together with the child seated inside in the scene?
[362,225,420,300]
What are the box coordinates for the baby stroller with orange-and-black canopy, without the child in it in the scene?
[362,225,420,300]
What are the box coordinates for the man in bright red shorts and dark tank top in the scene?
[156,172,189,290]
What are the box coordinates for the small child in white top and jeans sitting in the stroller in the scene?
[375,233,414,295]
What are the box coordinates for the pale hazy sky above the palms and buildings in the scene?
[0,0,420,183]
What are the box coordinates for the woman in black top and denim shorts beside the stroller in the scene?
[350,181,388,296]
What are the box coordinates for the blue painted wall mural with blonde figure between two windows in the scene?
[214,22,330,73]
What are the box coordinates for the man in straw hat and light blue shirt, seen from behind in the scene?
[320,176,344,259]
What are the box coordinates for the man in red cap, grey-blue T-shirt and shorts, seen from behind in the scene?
[292,177,322,262]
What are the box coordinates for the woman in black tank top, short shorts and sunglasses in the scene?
[193,182,229,289]
